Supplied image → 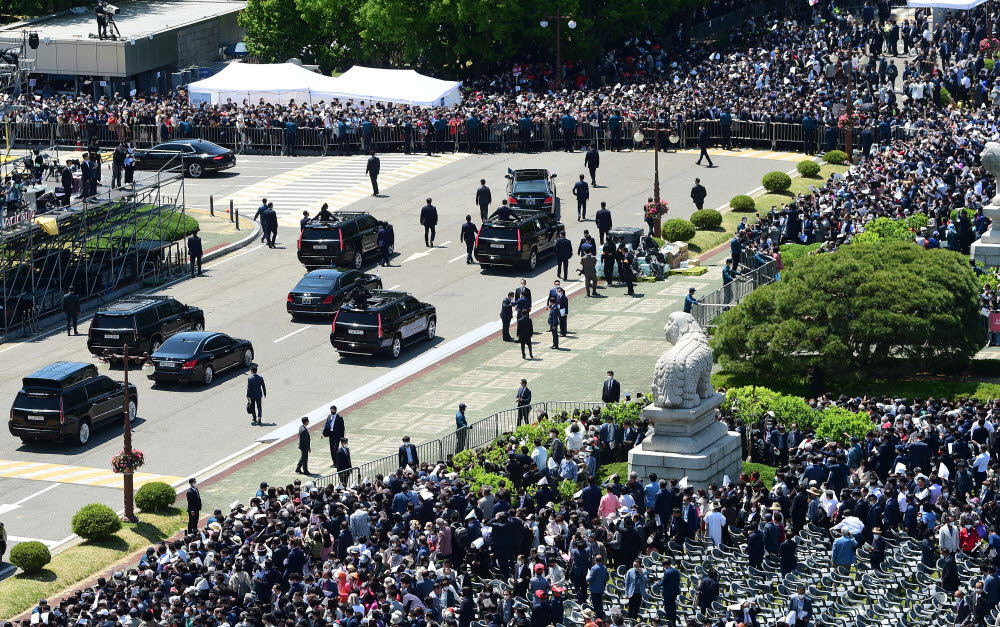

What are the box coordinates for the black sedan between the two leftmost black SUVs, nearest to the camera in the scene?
[149,331,253,385]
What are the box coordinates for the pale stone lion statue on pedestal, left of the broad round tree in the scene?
[653,311,713,409]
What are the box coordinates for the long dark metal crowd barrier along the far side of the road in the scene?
[3,119,876,155]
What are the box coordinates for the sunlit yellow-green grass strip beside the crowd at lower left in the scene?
[0,507,187,620]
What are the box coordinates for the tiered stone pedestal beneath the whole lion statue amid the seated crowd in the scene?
[628,393,743,486]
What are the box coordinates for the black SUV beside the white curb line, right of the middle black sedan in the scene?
[330,290,437,359]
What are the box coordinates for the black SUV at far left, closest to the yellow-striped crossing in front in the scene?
[7,361,139,446]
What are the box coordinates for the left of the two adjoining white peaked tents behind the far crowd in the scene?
[188,63,336,104]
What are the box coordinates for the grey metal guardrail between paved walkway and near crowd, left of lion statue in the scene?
[314,401,604,487]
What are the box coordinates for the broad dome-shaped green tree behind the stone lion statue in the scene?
[711,241,983,377]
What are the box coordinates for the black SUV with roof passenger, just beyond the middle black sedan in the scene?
[298,211,393,270]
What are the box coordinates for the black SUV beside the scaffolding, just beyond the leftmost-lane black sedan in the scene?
[87,296,205,355]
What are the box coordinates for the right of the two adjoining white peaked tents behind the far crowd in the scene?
[313,65,462,107]
